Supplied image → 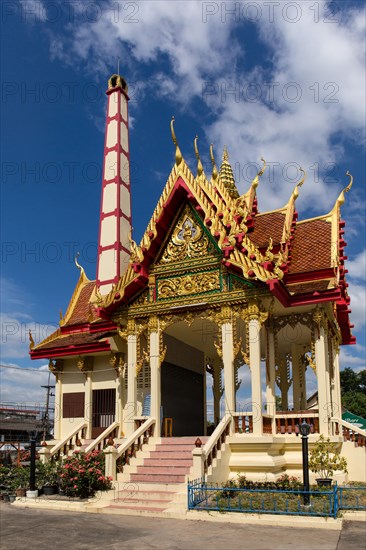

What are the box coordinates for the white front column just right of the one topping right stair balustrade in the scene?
[249,318,263,435]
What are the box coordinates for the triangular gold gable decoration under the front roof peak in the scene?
[157,205,219,266]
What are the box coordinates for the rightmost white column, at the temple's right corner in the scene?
[315,326,329,436]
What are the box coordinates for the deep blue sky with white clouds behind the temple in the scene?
[1,0,366,410]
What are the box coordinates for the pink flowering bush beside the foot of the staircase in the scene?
[60,451,112,498]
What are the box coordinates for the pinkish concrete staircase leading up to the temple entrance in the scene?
[90,436,208,517]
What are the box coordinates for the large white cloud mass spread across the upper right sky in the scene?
[28,0,365,218]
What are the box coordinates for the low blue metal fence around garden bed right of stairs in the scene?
[188,479,366,518]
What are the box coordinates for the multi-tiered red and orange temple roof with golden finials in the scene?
[31,119,355,359]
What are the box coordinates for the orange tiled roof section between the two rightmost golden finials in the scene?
[289,220,332,274]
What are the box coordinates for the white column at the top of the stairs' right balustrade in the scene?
[221,321,236,414]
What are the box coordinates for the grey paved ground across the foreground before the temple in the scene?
[0,503,366,550]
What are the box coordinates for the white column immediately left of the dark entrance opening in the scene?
[149,321,162,437]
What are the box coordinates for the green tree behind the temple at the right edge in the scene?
[341,367,366,418]
